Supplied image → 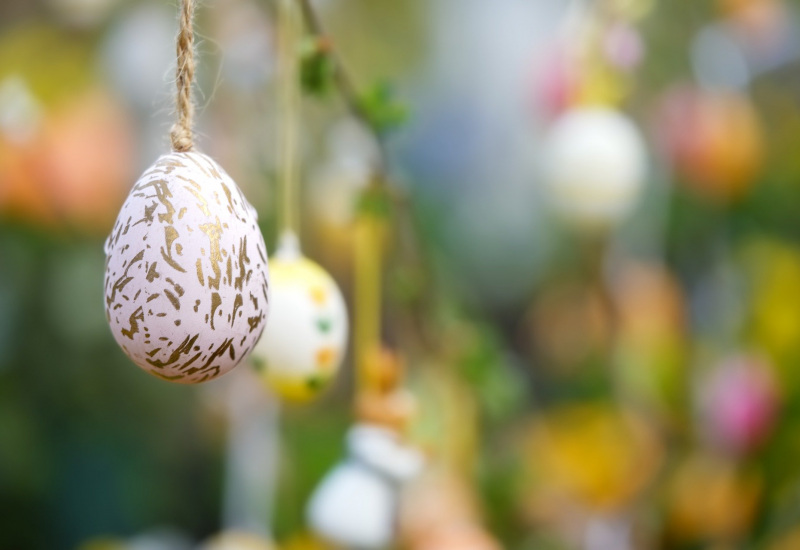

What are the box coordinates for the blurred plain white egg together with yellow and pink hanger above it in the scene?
[543,1,650,228]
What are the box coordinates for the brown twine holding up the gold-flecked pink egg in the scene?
[170,0,195,153]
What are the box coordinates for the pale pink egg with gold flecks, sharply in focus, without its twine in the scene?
[105,151,269,384]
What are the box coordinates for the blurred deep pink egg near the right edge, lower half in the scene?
[699,356,779,454]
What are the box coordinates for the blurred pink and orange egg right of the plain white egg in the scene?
[655,86,766,203]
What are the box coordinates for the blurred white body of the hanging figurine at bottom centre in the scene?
[307,424,424,550]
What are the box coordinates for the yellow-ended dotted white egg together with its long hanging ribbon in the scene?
[253,0,348,401]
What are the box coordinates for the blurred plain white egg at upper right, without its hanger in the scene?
[544,107,647,227]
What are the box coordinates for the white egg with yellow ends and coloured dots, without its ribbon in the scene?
[251,234,348,401]
